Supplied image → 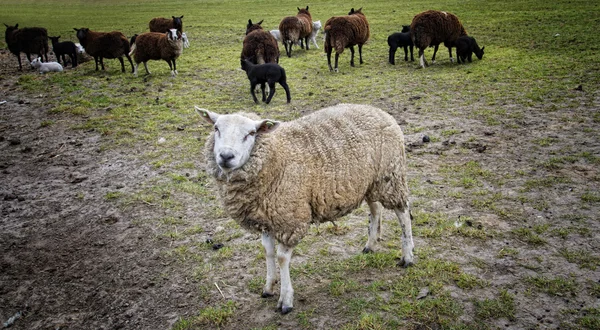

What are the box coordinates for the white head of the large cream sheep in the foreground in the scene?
[195,107,279,173]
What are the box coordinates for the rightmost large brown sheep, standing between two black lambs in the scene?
[410,10,467,68]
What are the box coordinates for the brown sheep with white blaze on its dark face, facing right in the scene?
[129,29,183,77]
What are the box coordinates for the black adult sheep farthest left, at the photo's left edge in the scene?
[4,24,48,70]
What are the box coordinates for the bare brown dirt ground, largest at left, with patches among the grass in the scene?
[0,48,600,329]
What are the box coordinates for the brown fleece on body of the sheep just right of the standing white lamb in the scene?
[324,12,371,54]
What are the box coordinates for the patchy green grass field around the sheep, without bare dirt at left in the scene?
[0,0,600,329]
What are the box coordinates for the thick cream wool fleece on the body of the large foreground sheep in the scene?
[205,104,408,247]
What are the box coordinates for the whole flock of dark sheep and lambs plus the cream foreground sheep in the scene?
[6,7,483,314]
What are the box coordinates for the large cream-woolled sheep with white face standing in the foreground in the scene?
[196,104,414,314]
